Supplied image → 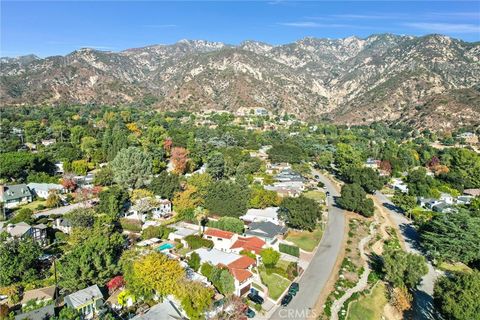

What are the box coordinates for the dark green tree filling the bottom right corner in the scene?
[433,271,480,320]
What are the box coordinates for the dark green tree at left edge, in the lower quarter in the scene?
[0,238,42,286]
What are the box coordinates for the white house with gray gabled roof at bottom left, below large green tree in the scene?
[64,285,104,319]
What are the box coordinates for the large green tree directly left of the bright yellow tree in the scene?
[58,226,125,290]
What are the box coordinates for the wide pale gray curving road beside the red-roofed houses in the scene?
[270,171,345,320]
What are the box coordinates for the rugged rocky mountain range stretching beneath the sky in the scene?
[0,34,480,130]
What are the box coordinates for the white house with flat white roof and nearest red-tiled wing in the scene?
[194,248,257,296]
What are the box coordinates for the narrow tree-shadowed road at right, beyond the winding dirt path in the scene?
[375,192,441,320]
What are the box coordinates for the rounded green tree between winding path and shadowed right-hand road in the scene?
[383,247,428,289]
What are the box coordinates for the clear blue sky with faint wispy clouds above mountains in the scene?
[0,0,480,57]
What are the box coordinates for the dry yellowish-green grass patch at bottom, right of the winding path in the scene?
[347,282,387,320]
